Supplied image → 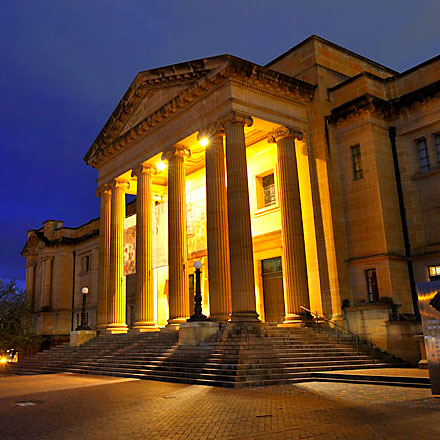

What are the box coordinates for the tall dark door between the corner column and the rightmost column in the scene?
[261,257,285,323]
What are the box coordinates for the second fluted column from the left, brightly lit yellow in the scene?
[106,180,129,333]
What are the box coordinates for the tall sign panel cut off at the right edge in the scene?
[417,281,440,394]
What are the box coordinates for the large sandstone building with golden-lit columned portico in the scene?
[23,36,440,358]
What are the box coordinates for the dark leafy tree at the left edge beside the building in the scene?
[0,279,32,350]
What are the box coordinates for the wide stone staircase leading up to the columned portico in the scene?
[8,324,398,388]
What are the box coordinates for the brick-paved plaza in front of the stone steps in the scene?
[0,374,440,440]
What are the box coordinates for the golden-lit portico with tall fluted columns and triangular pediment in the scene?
[86,56,313,333]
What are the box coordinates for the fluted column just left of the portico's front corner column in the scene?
[201,129,231,321]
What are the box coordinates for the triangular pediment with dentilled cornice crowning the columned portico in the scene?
[84,55,315,167]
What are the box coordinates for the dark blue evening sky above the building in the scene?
[0,0,440,286]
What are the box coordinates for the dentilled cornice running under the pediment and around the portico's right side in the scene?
[84,55,315,167]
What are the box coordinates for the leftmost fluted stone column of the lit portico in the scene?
[97,185,112,330]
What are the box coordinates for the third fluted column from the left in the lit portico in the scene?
[132,164,158,332]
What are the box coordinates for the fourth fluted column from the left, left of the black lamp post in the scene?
[163,145,191,325]
